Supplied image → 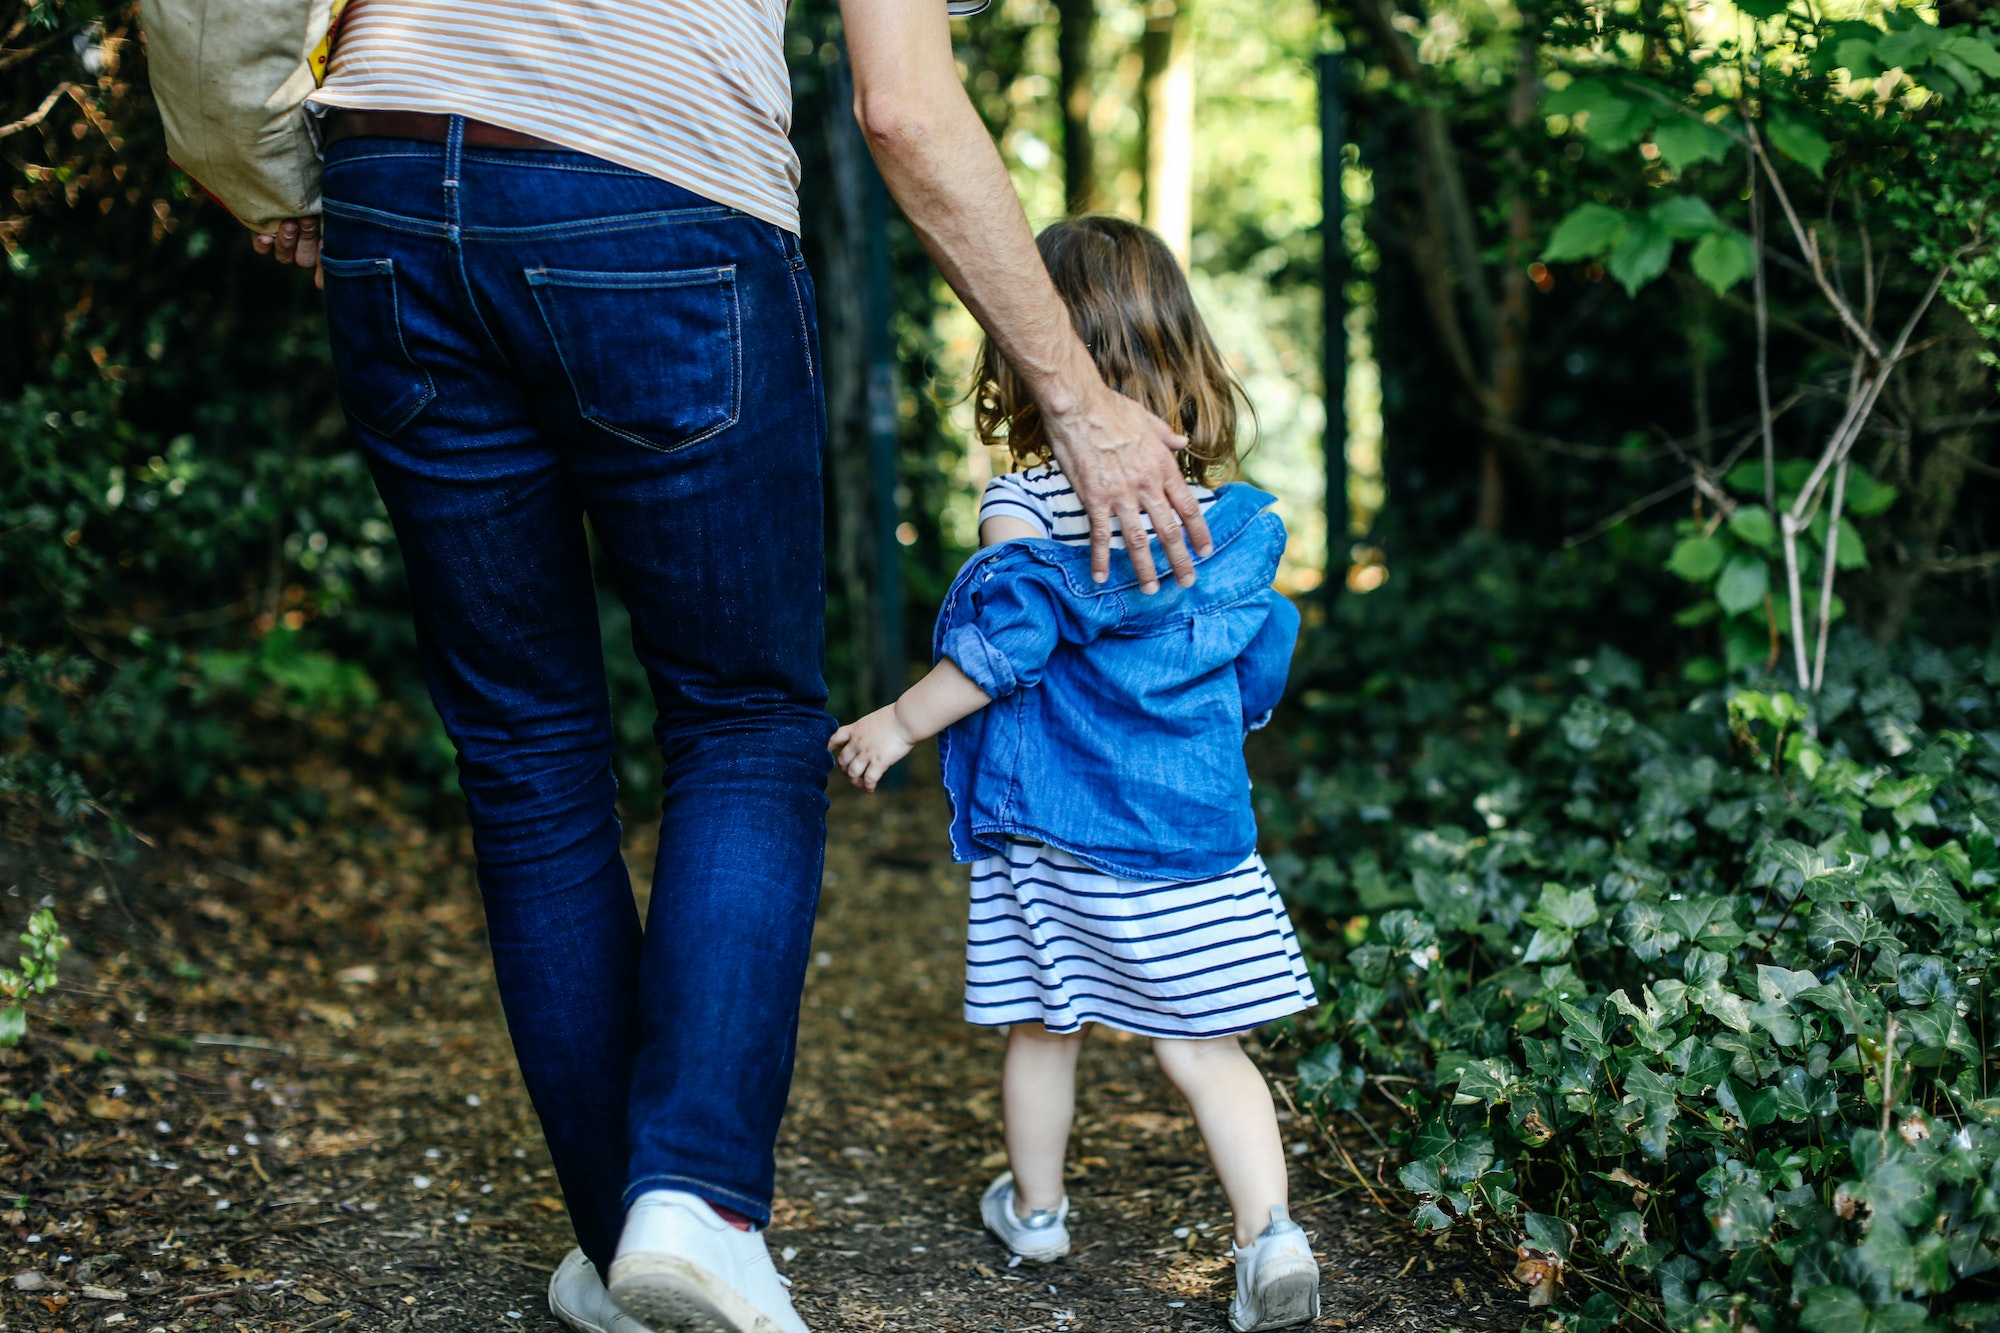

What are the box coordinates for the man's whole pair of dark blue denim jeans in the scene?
[322,124,832,1271]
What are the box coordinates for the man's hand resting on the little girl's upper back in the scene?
[1042,370,1214,592]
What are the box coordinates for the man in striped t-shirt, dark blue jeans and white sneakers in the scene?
[256,0,1208,1333]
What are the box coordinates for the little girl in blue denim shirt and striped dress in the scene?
[832,218,1320,1333]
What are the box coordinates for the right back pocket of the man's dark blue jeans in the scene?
[528,264,742,450]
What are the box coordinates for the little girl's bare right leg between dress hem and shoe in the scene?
[1152,1029,1288,1247]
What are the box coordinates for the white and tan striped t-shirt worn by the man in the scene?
[312,0,984,232]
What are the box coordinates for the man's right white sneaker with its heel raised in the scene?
[610,1189,810,1333]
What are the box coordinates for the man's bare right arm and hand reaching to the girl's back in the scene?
[840,0,1212,592]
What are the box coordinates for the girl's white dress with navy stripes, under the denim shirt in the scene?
[966,464,1318,1039]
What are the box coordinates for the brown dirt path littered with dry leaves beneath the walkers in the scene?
[0,772,1526,1333]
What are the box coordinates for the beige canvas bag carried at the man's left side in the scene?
[140,0,346,232]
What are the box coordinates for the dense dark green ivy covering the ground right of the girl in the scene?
[1264,544,2000,1333]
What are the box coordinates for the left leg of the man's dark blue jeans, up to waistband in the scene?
[326,140,640,1269]
